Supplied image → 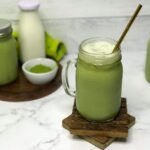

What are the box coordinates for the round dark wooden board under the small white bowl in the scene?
[0,65,62,102]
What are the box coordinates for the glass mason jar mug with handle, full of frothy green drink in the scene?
[62,38,123,121]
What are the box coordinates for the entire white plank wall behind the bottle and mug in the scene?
[0,0,150,53]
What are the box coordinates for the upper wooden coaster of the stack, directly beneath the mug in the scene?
[63,99,130,138]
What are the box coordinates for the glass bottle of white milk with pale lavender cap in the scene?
[18,0,45,62]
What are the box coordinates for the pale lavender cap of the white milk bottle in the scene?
[18,0,40,10]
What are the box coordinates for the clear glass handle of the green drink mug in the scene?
[61,59,77,97]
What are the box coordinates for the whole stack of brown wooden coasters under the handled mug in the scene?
[62,98,135,149]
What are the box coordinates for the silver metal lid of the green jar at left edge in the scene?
[0,19,12,38]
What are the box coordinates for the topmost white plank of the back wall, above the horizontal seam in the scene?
[0,0,150,20]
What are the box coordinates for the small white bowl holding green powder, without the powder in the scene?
[22,58,58,84]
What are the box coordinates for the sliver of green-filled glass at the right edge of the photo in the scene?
[145,39,150,82]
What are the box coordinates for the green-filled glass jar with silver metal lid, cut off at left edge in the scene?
[0,19,18,85]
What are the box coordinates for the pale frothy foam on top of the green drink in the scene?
[83,41,115,54]
